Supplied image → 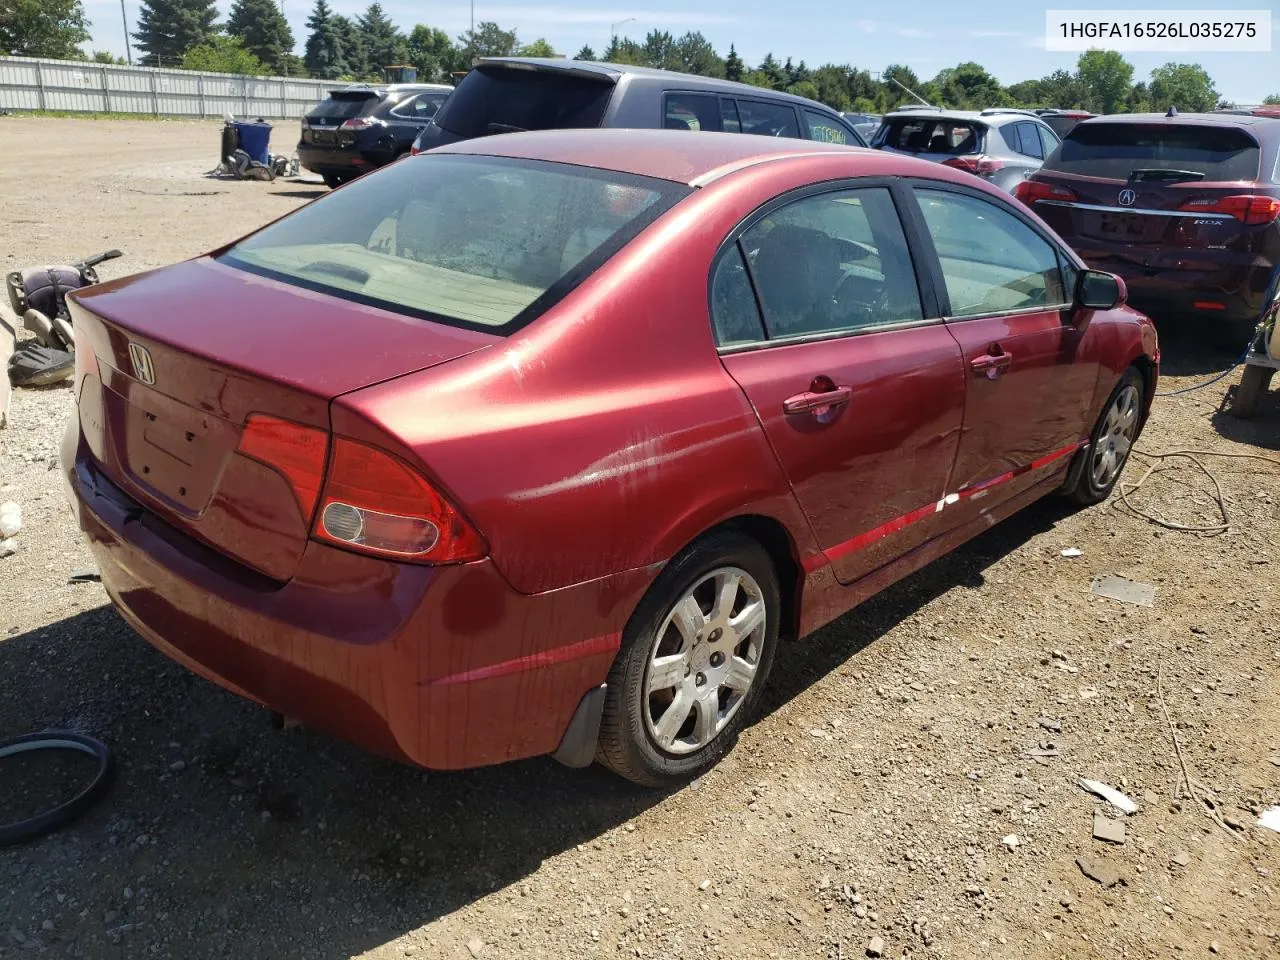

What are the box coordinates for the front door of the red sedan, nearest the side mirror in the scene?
[914,182,1098,520]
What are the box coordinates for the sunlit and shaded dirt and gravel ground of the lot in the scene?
[0,118,1280,960]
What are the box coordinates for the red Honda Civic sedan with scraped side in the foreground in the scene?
[61,131,1158,785]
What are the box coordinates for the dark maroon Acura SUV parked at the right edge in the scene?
[1018,114,1280,339]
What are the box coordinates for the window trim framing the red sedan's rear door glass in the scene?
[707,177,945,356]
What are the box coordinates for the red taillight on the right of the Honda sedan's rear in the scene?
[314,436,485,563]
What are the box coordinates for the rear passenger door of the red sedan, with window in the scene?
[712,182,965,584]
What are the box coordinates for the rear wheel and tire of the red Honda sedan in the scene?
[596,531,782,787]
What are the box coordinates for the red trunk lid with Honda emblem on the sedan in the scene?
[64,259,498,581]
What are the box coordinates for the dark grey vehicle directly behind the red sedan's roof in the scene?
[413,56,867,152]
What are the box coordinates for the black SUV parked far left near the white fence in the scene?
[298,83,453,187]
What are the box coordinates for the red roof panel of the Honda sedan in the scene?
[422,128,883,186]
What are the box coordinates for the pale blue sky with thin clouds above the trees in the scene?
[84,0,1280,104]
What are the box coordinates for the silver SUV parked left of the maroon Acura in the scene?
[872,106,1059,192]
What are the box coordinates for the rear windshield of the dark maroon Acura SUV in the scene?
[1044,122,1260,180]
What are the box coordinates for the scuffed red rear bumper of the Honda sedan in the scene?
[61,419,653,769]
